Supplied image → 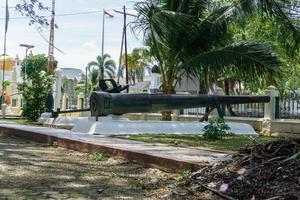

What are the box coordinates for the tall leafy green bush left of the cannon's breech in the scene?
[18,55,53,121]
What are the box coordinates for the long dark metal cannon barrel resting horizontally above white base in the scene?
[90,92,270,117]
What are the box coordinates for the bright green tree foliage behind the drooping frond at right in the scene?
[229,16,300,94]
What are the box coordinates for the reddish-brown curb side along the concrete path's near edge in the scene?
[0,126,209,172]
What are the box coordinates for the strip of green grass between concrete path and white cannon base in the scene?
[128,134,276,151]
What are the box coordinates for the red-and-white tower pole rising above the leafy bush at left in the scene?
[47,0,55,74]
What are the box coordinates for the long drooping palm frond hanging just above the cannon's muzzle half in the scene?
[184,41,281,77]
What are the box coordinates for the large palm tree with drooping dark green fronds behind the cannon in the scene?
[133,0,299,119]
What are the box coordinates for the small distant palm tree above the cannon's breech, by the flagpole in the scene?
[88,54,116,80]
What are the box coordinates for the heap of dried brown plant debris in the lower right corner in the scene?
[170,139,300,200]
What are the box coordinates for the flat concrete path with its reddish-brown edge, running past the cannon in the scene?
[0,121,231,171]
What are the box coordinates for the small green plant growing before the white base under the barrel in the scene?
[203,118,231,140]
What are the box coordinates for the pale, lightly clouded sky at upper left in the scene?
[0,0,142,70]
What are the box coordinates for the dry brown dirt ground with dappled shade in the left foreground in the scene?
[0,134,188,200]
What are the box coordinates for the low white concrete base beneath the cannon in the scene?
[45,116,258,135]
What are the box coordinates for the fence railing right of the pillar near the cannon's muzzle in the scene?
[275,97,300,119]
